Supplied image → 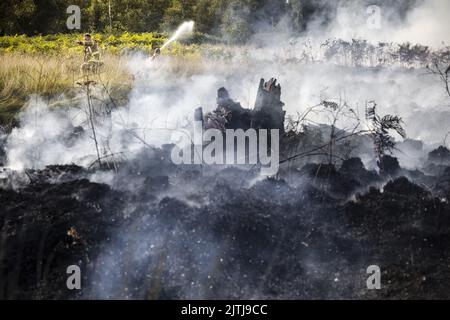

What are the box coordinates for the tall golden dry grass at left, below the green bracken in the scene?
[0,53,132,124]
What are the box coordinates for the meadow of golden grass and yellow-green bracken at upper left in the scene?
[0,33,221,127]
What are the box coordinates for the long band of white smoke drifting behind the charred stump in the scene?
[6,49,450,168]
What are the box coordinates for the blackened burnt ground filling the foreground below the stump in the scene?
[0,145,450,299]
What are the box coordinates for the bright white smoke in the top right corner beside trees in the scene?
[308,0,450,47]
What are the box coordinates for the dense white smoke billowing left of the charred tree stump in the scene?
[6,55,225,169]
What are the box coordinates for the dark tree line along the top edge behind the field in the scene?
[0,0,320,41]
